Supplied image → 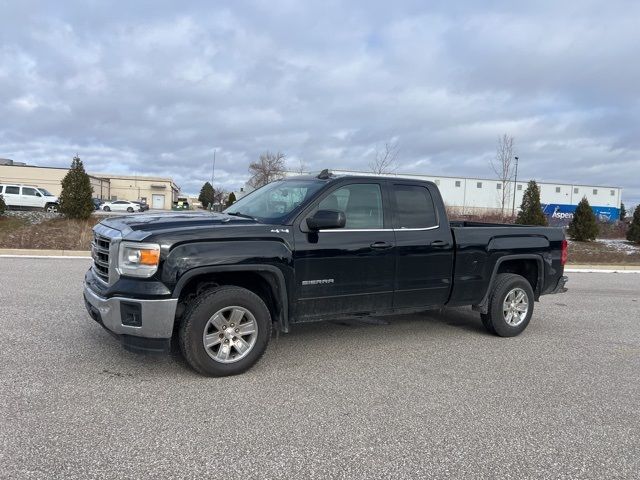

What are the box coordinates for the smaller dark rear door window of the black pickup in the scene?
[394,185,438,228]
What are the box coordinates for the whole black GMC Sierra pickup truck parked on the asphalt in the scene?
[84,170,567,376]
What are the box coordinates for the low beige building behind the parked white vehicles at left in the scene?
[0,161,180,210]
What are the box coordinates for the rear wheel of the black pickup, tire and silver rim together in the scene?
[481,273,534,337]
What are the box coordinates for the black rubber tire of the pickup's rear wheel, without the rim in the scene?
[480,273,534,337]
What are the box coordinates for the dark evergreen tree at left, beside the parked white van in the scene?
[59,155,95,220]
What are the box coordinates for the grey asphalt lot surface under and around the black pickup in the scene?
[0,258,640,479]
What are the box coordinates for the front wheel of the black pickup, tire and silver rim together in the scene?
[179,286,271,377]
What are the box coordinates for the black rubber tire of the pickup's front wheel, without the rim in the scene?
[178,286,272,377]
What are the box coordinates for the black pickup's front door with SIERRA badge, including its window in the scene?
[294,180,396,320]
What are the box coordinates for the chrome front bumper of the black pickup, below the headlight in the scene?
[84,284,178,351]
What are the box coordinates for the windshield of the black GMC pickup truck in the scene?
[224,180,325,223]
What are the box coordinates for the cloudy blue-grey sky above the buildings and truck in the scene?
[0,0,640,204]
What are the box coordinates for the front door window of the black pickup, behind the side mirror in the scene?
[318,183,383,229]
